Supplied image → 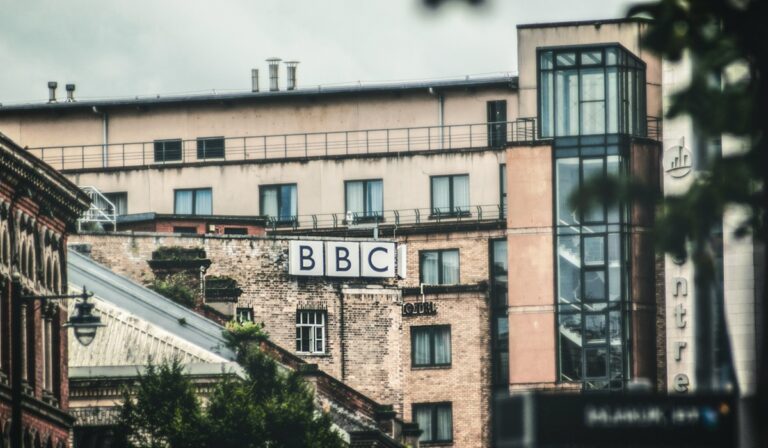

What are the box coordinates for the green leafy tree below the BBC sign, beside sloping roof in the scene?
[113,323,344,448]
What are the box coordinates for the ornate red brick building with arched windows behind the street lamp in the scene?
[0,134,88,448]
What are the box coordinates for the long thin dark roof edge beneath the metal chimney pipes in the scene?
[0,74,518,115]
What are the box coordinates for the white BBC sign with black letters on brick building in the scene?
[288,241,406,278]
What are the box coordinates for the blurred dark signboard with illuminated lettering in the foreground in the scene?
[494,393,736,448]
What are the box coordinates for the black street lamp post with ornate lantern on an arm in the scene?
[11,272,104,447]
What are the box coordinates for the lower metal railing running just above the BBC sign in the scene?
[260,204,506,231]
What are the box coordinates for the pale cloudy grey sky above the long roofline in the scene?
[0,0,634,104]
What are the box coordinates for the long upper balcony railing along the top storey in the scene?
[29,118,538,171]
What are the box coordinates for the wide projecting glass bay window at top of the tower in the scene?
[538,46,646,137]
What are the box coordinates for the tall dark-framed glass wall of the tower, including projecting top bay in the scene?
[539,45,646,389]
